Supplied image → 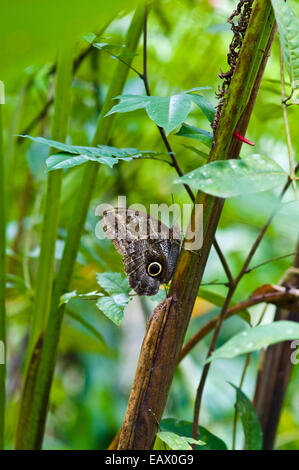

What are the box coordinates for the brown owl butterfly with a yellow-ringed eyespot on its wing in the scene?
[101,208,181,295]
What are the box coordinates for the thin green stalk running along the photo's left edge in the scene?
[0,104,6,449]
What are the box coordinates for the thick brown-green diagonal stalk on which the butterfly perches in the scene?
[118,0,274,450]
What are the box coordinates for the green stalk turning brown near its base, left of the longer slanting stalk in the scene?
[16,43,73,448]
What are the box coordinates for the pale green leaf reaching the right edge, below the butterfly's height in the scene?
[206,321,299,362]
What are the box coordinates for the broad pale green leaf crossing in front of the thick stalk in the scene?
[174,154,287,198]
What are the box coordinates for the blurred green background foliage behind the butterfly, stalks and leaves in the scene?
[0,0,299,449]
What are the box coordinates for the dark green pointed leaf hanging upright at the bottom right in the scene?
[230,383,263,450]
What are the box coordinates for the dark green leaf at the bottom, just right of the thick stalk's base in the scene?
[160,418,227,450]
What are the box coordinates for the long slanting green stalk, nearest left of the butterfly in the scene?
[17,7,144,449]
